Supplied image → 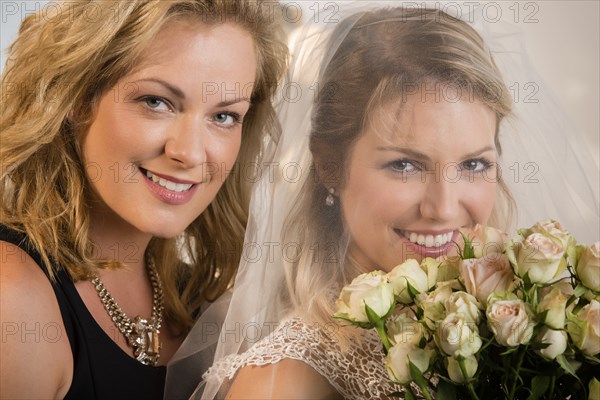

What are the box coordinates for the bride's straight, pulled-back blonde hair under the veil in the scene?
[283,8,514,332]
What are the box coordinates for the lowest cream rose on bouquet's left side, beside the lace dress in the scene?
[385,343,432,385]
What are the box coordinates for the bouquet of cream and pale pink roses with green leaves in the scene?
[334,221,600,400]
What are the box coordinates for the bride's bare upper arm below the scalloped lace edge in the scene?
[227,359,342,399]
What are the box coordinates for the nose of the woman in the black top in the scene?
[165,118,207,169]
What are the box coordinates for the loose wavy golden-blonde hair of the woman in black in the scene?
[0,0,287,333]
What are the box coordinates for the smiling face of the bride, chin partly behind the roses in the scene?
[339,93,497,270]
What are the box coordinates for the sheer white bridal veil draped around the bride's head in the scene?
[165,1,600,399]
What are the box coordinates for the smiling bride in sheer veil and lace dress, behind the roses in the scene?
[165,1,598,399]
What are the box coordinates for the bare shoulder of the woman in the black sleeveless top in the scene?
[0,241,73,399]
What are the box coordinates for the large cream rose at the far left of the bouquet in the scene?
[334,271,395,323]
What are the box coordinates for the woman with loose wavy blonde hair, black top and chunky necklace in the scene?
[0,0,287,399]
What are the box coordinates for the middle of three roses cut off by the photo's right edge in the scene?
[567,300,600,356]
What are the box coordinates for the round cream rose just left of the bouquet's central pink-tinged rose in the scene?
[434,313,481,358]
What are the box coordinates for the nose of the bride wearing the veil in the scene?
[420,176,462,222]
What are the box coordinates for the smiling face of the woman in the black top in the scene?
[83,21,256,237]
